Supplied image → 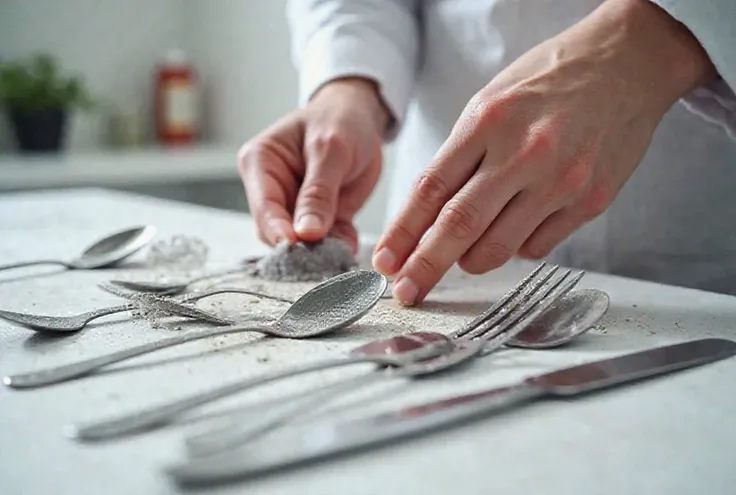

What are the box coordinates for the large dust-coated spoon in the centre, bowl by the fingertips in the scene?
[3,270,388,388]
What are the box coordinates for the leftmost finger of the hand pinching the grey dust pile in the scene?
[239,148,298,246]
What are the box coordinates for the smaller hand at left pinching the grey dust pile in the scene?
[238,78,389,254]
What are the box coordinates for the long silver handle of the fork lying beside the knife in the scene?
[70,356,396,440]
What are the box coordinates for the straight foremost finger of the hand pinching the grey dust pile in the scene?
[294,133,351,241]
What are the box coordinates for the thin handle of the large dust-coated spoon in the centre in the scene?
[3,325,269,388]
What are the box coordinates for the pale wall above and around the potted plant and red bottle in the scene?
[0,0,183,150]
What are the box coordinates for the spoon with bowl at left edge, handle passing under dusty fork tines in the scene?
[0,287,293,333]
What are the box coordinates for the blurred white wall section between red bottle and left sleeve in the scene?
[185,0,297,143]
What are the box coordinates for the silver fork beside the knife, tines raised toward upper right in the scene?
[68,262,584,440]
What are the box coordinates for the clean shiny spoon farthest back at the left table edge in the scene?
[0,225,156,276]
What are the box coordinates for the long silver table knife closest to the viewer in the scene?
[166,338,736,485]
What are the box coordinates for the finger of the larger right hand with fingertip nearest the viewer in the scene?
[394,168,519,305]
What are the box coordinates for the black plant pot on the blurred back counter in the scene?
[8,107,67,152]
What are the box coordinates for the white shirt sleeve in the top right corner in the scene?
[652,0,736,140]
